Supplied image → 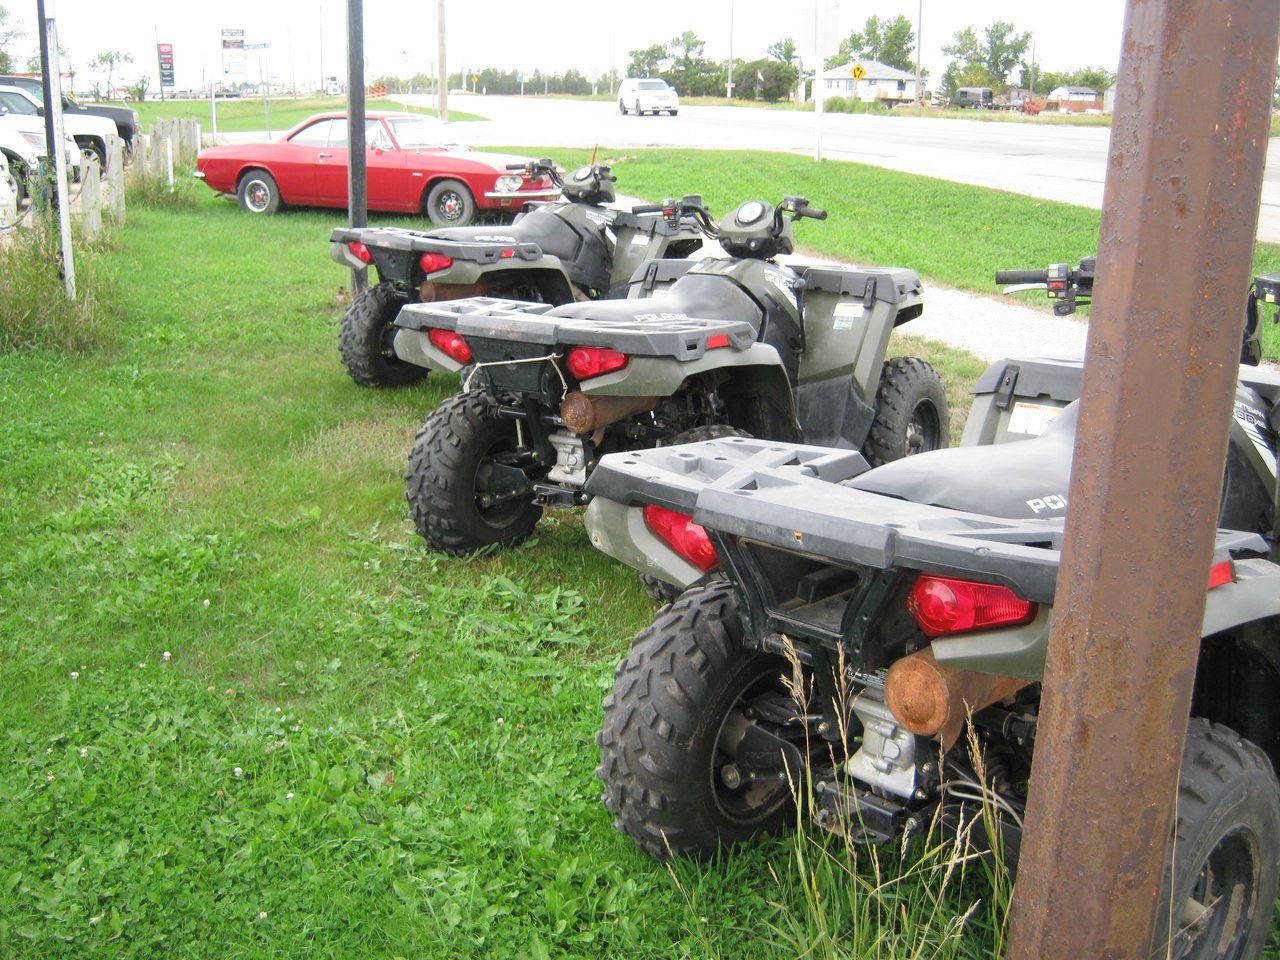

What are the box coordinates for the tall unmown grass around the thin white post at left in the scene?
[0,220,114,353]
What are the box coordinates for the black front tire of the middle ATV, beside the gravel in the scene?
[863,357,951,467]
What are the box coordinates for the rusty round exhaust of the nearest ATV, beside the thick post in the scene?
[884,648,1030,748]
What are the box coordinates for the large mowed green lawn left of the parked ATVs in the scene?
[0,185,997,960]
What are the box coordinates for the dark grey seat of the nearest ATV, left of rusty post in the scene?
[845,401,1080,520]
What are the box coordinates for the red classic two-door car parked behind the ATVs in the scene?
[196,111,559,227]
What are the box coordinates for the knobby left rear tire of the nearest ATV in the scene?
[595,582,801,859]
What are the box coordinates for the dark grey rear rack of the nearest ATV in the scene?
[585,438,1267,604]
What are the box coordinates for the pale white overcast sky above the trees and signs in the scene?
[15,0,1124,88]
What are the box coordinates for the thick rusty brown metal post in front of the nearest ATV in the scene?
[1007,0,1280,960]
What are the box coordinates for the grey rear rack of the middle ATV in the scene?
[396,297,755,360]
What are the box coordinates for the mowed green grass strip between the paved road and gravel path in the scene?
[512,147,1280,361]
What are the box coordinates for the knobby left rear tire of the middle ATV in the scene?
[404,390,543,557]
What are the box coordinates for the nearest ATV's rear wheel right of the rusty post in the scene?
[1152,718,1280,960]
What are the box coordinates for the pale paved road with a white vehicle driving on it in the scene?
[408,96,1280,243]
